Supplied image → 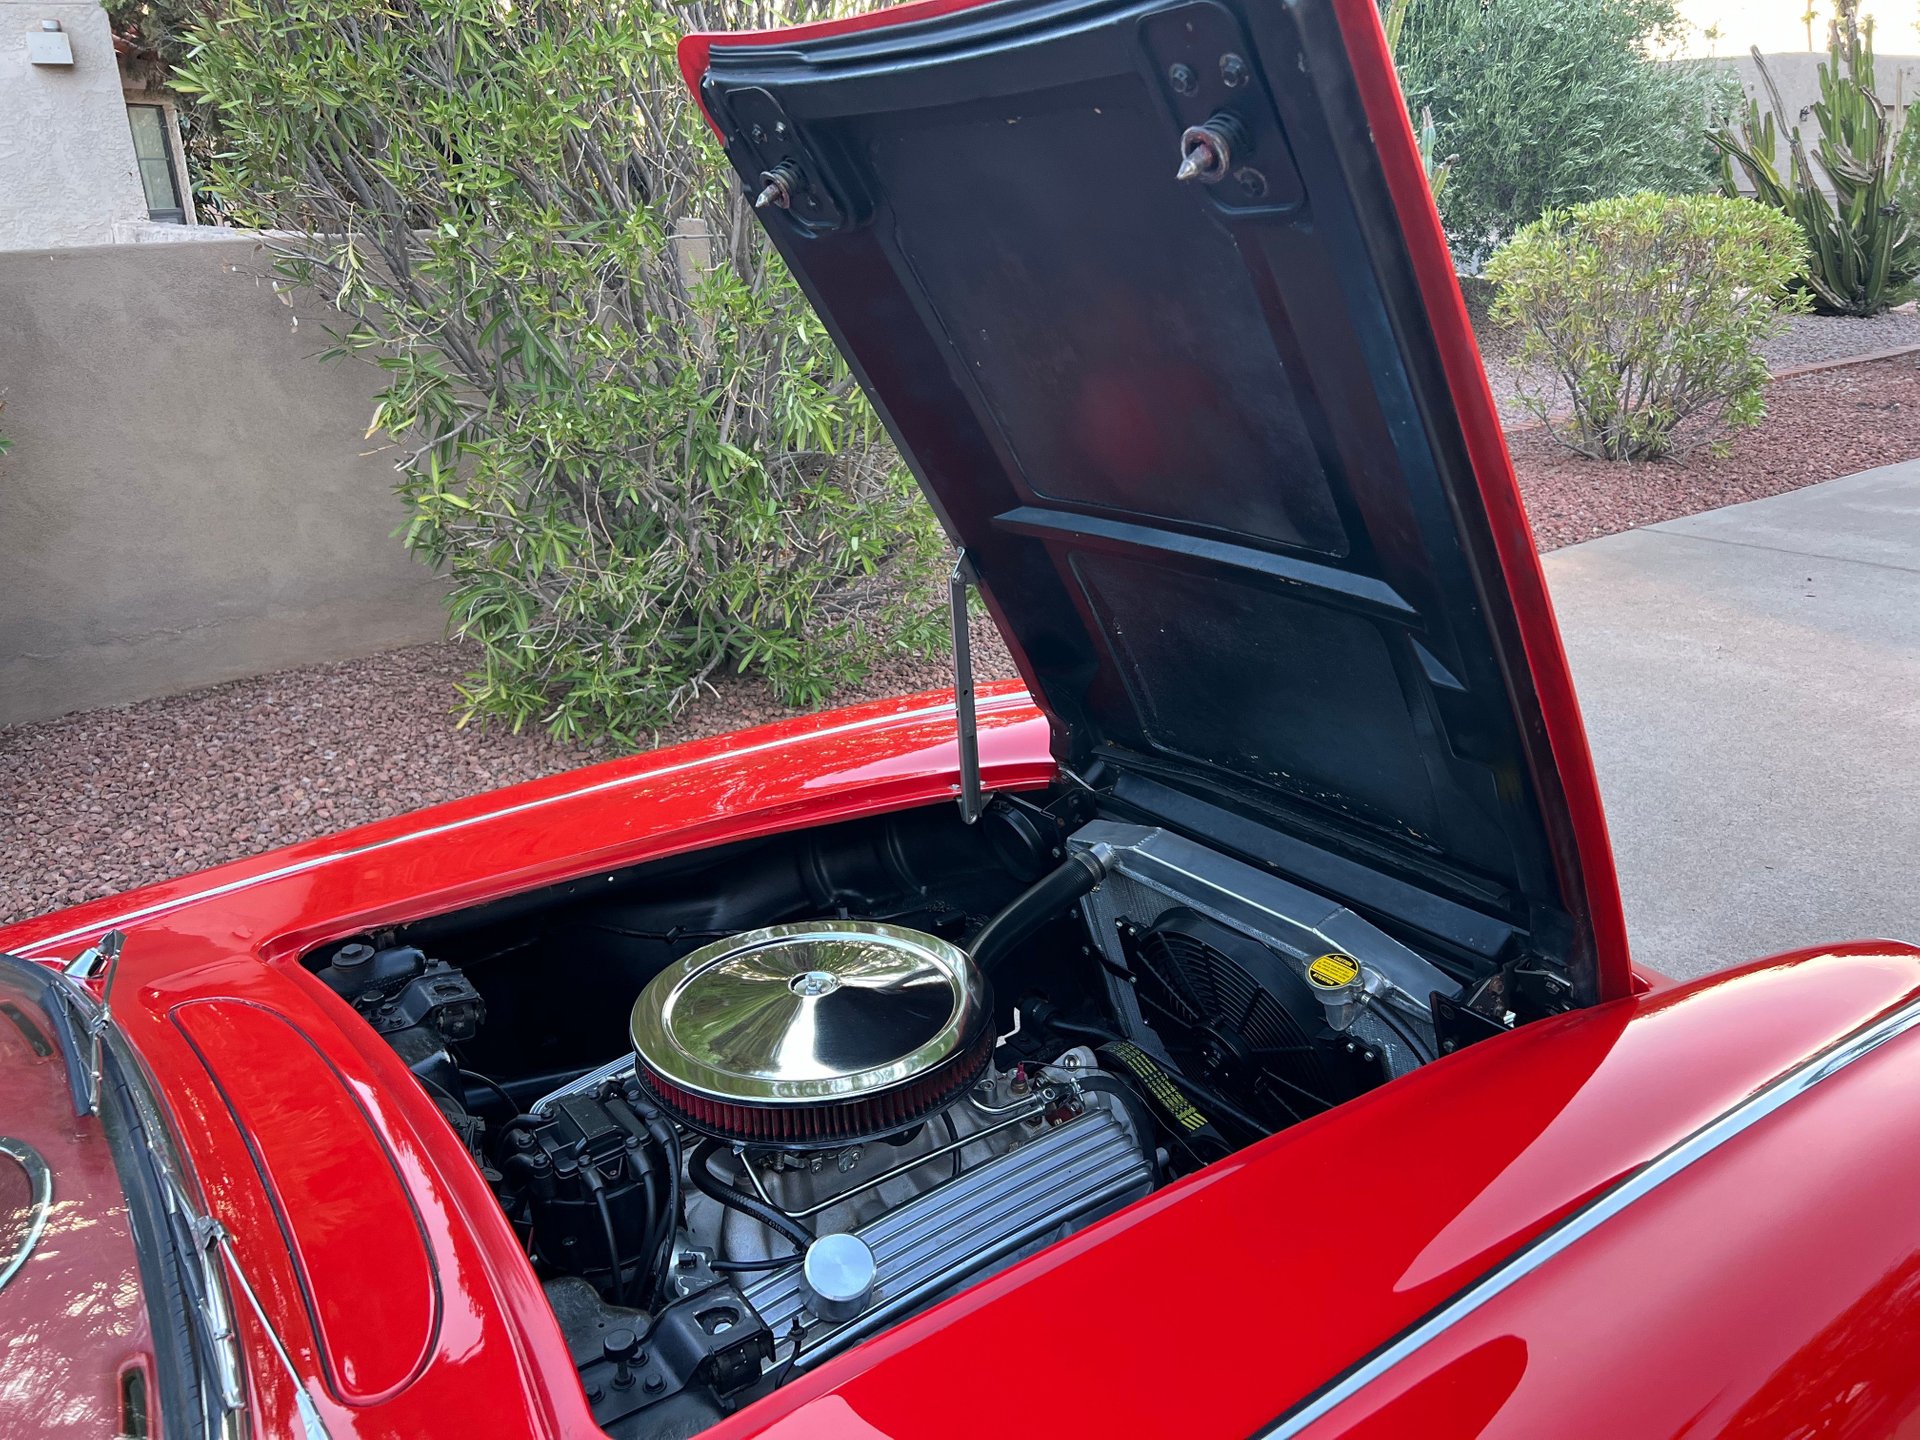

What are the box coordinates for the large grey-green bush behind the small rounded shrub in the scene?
[1396,0,1738,269]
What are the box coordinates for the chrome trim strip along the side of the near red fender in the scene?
[1256,1000,1920,1440]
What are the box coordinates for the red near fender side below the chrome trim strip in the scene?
[1306,963,1920,1440]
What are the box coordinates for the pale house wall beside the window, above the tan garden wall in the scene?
[0,0,149,250]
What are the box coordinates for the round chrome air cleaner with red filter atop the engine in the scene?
[632,920,993,1144]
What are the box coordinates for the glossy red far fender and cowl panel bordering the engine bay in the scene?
[0,684,1054,1438]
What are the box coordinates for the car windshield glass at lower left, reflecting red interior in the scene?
[0,966,154,1438]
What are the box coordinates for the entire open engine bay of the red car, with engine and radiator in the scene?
[307,795,1536,1440]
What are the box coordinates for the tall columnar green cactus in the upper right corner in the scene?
[1707,0,1920,315]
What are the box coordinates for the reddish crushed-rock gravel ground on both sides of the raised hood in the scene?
[0,357,1920,922]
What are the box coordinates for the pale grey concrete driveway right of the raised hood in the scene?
[1546,461,1920,975]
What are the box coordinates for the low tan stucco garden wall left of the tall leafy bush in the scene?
[0,242,445,724]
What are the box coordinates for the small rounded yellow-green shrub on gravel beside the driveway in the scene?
[1486,194,1807,461]
